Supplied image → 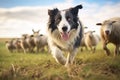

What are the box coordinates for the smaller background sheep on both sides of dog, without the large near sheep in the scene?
[6,30,100,53]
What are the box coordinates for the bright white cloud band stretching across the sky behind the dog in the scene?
[0,0,120,37]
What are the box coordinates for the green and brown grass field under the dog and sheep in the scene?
[0,39,120,80]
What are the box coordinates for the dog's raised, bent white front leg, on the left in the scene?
[52,46,66,65]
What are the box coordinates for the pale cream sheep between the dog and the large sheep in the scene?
[81,31,100,53]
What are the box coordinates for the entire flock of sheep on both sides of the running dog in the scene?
[6,17,120,55]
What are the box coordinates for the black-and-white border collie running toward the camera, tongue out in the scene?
[47,5,83,67]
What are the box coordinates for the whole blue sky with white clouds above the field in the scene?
[0,0,120,37]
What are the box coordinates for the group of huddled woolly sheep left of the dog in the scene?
[6,30,48,53]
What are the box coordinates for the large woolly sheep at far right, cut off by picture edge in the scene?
[96,17,120,56]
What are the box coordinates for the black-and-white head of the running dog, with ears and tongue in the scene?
[48,5,82,40]
